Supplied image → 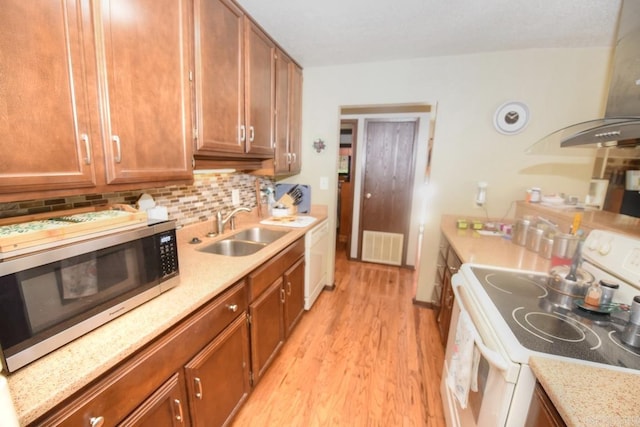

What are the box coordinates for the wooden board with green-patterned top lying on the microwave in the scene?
[0,209,147,253]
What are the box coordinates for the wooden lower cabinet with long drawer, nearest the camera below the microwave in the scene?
[32,280,249,427]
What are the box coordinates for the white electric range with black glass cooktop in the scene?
[441,230,640,427]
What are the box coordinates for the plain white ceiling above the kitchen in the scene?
[237,0,620,67]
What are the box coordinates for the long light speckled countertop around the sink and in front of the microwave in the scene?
[0,206,327,425]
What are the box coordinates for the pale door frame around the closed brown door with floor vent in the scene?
[354,117,420,266]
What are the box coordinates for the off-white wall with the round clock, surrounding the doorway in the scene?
[289,49,610,301]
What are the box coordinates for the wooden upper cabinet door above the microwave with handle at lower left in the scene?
[95,0,193,184]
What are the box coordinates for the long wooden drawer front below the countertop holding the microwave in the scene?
[33,280,247,427]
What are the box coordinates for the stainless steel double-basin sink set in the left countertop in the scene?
[198,227,289,257]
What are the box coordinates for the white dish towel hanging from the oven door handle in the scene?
[447,311,480,409]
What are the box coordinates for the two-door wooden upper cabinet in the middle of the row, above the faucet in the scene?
[194,0,275,158]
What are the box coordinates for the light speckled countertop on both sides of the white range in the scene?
[441,214,640,427]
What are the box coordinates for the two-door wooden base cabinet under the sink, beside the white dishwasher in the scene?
[248,238,304,386]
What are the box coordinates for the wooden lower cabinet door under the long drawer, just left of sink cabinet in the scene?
[185,314,250,427]
